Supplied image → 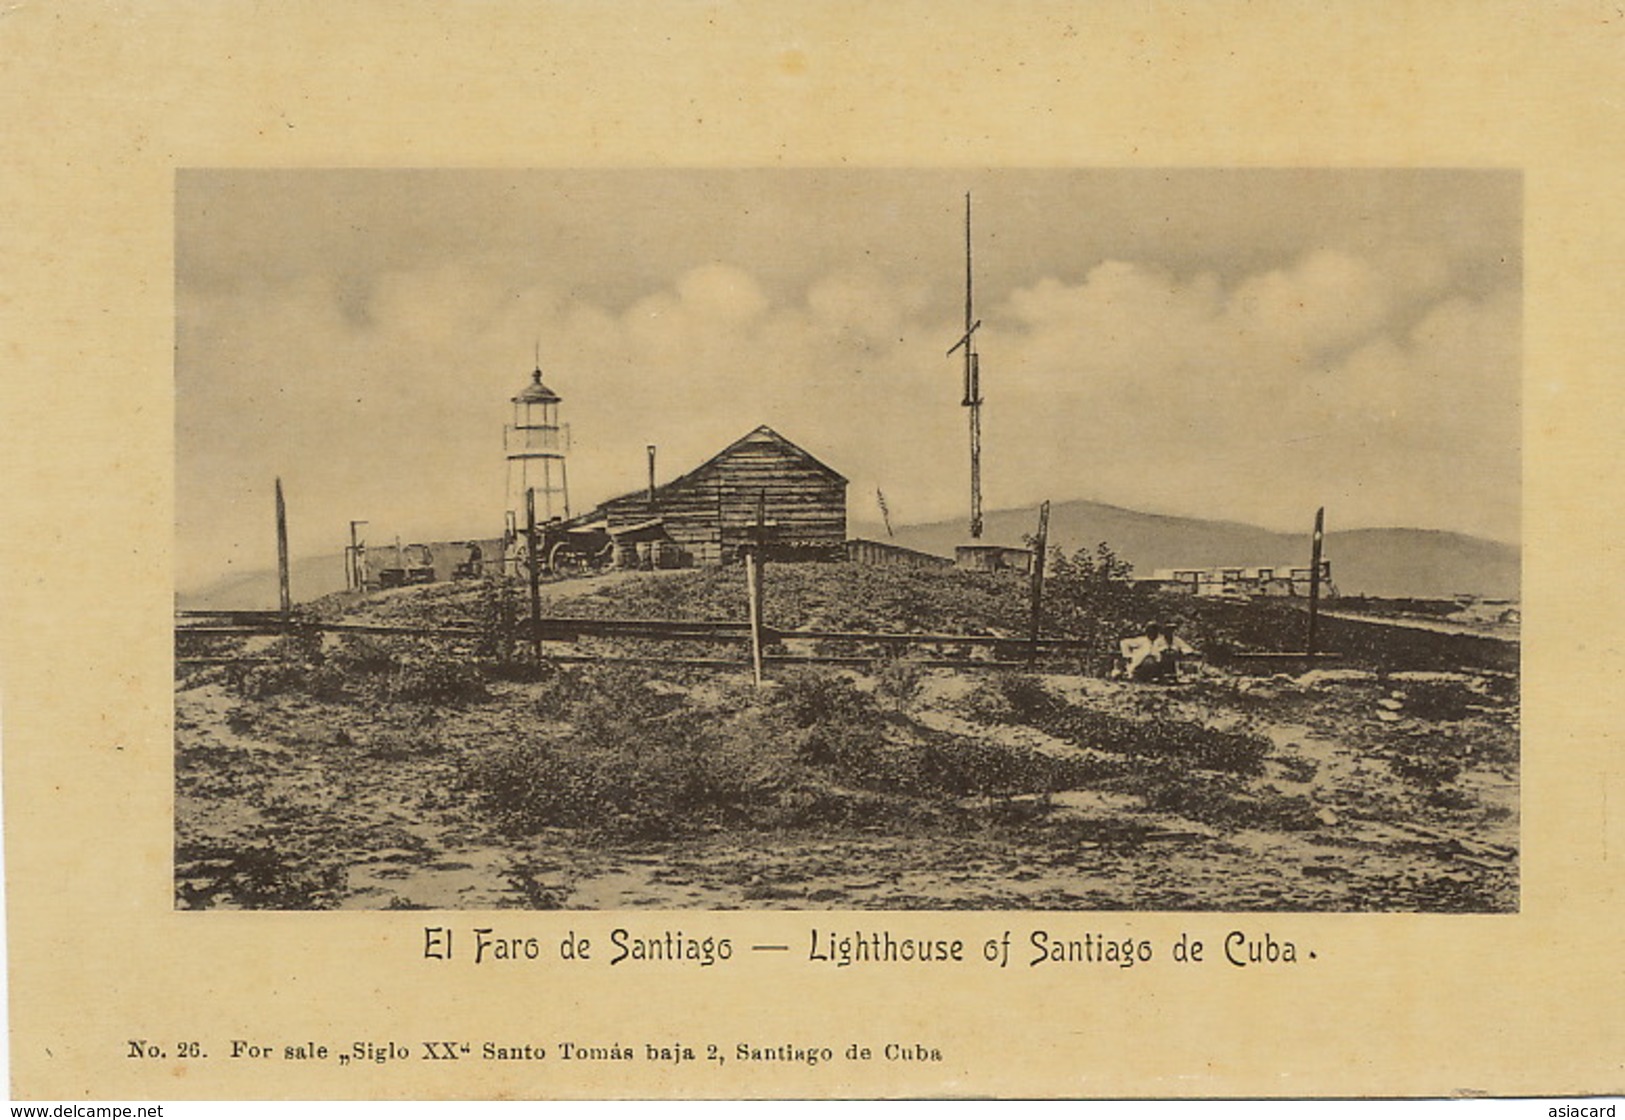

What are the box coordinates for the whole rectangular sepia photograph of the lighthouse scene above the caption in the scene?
[174,167,1524,914]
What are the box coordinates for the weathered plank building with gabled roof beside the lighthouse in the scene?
[569,424,847,567]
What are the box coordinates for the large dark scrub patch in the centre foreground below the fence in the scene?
[465,666,1100,839]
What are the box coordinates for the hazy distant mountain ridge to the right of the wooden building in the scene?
[852,501,1521,598]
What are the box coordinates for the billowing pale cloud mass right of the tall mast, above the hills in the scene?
[983,250,1521,540]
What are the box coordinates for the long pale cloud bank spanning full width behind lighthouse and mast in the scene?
[177,249,1519,585]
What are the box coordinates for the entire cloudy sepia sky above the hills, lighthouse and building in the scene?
[176,169,1523,590]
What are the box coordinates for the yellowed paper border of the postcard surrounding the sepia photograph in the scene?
[0,3,1625,1099]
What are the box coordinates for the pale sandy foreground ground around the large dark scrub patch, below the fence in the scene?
[176,620,1519,912]
